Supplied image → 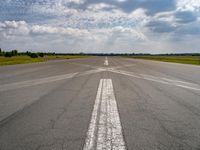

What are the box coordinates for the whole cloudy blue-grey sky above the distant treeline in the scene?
[0,0,200,54]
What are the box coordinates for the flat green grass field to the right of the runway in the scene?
[129,56,200,65]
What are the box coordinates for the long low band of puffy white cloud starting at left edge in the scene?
[0,21,144,39]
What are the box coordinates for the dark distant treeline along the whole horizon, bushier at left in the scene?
[0,48,200,58]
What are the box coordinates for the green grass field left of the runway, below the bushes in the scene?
[0,55,88,66]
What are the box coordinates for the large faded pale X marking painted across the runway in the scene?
[0,64,200,92]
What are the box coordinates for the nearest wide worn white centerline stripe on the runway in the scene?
[83,79,126,150]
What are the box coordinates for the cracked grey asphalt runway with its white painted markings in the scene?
[0,57,200,150]
